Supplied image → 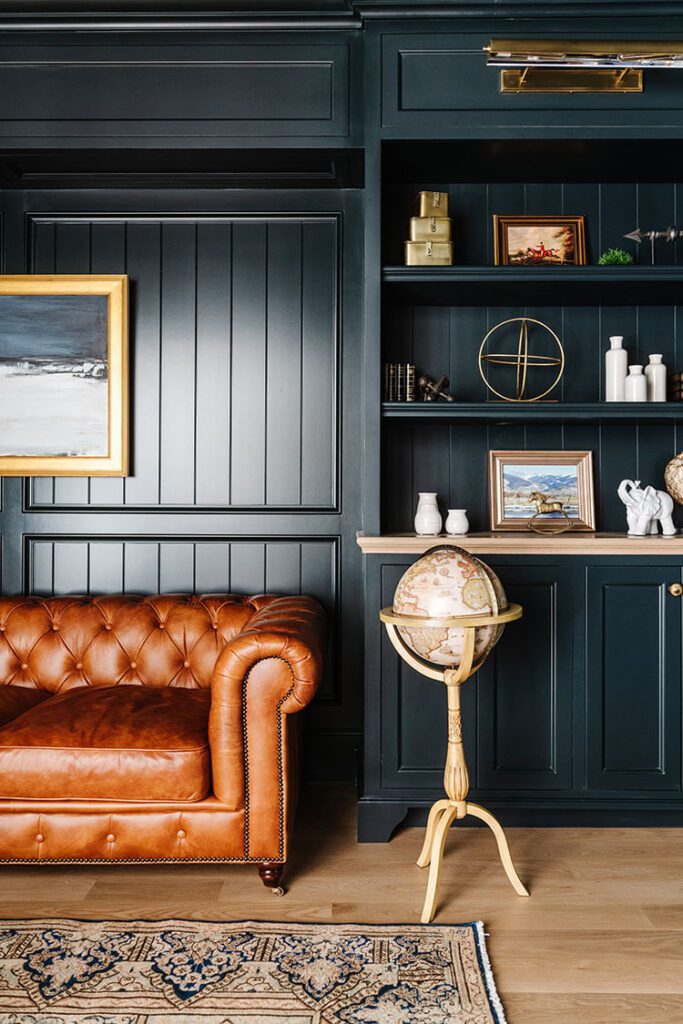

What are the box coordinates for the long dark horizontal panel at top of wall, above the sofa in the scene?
[0,44,348,139]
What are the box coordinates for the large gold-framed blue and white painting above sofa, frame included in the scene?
[0,274,128,476]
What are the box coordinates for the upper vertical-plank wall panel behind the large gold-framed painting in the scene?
[30,214,341,511]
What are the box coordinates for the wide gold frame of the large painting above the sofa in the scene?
[0,273,128,476]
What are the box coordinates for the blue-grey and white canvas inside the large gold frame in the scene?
[0,295,109,456]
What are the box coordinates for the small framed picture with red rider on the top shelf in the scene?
[494,214,586,266]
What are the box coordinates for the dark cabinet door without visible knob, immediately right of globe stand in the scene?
[477,565,572,790]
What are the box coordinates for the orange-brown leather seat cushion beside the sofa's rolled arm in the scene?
[0,686,211,803]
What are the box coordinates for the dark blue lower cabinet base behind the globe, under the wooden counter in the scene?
[366,555,683,843]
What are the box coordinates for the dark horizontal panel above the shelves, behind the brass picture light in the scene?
[382,33,683,134]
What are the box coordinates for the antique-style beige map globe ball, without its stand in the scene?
[393,544,508,669]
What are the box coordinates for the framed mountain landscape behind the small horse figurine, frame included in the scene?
[488,451,595,534]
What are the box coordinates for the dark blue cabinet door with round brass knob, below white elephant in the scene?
[586,564,682,791]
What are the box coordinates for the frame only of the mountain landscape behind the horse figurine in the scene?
[488,450,595,532]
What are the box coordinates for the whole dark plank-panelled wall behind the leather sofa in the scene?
[0,189,361,779]
